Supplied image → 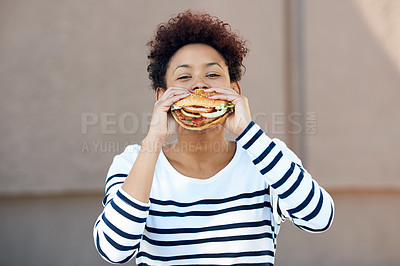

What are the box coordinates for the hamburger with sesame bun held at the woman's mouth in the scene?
[171,89,235,130]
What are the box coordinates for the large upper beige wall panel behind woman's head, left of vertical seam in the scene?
[0,0,284,194]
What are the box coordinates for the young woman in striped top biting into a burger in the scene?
[94,11,334,265]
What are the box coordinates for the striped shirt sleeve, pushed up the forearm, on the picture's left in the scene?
[93,145,150,263]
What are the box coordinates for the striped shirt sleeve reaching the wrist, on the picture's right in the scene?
[236,121,334,232]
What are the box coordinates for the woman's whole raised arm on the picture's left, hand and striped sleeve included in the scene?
[93,88,189,263]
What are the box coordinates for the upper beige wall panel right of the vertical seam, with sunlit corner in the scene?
[304,0,400,188]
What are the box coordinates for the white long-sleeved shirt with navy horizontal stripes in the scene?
[93,122,334,265]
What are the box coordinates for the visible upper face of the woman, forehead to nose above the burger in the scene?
[165,43,231,90]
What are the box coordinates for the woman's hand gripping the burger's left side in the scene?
[146,87,190,145]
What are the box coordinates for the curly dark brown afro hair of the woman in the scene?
[147,10,248,90]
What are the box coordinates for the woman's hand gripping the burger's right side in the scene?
[205,87,251,136]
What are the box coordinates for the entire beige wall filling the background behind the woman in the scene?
[0,0,400,265]
